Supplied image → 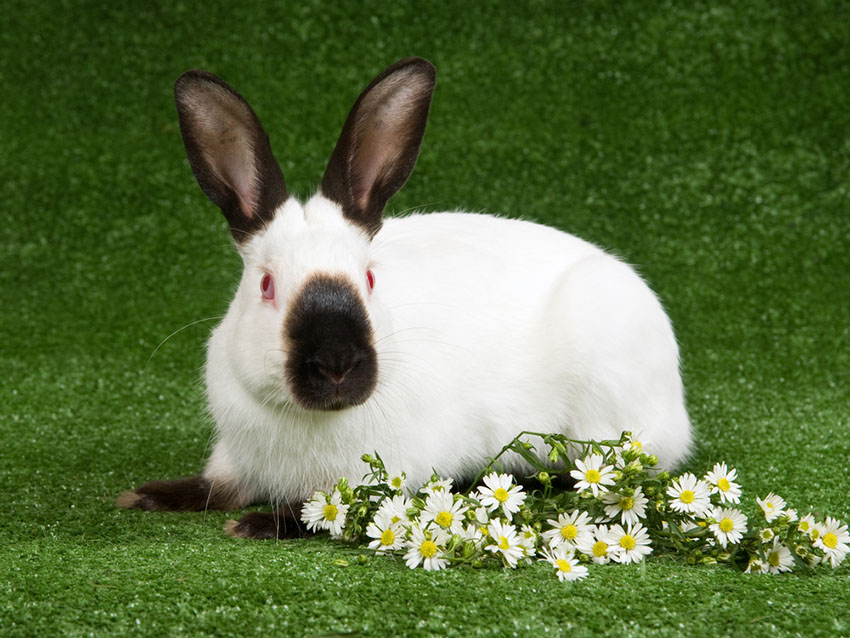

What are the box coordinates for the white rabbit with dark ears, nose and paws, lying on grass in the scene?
[117,58,691,538]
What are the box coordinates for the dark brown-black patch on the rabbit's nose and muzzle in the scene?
[283,274,378,410]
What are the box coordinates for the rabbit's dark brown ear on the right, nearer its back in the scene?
[320,58,436,236]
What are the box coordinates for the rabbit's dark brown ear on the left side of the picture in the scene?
[174,71,286,244]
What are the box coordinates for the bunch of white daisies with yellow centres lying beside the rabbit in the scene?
[302,432,850,581]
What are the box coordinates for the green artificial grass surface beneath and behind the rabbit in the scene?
[0,0,850,636]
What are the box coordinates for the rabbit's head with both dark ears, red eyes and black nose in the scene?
[175,58,435,410]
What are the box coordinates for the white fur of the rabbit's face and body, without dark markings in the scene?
[204,195,690,503]
